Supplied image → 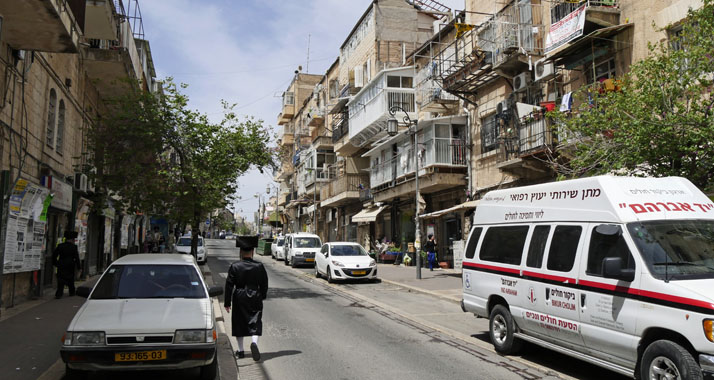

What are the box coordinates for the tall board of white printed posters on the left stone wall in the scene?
[3,179,50,273]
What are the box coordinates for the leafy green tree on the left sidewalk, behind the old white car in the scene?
[89,79,274,252]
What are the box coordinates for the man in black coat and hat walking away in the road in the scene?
[224,236,268,361]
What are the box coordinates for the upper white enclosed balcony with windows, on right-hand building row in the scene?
[347,68,416,147]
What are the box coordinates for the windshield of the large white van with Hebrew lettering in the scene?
[627,220,714,280]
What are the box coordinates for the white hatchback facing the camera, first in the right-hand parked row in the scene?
[315,242,377,282]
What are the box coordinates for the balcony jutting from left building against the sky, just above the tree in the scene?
[83,13,143,97]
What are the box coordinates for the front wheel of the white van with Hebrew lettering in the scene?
[640,340,704,380]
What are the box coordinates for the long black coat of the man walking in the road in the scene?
[224,259,268,336]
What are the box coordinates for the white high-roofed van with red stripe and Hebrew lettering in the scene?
[462,176,714,379]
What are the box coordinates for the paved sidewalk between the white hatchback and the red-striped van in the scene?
[377,264,462,303]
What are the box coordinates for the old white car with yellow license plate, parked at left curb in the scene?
[60,254,223,379]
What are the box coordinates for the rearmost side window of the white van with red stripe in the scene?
[479,226,528,265]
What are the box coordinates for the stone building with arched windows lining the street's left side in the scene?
[0,0,158,308]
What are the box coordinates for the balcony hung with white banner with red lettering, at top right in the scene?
[545,0,620,56]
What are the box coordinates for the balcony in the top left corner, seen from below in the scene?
[0,0,84,53]
